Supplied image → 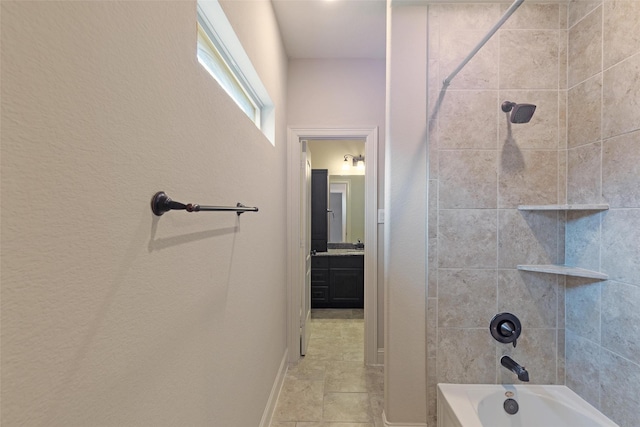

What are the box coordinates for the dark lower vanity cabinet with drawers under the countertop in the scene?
[311,255,364,308]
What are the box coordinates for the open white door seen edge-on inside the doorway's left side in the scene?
[300,140,311,356]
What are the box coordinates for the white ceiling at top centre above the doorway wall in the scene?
[271,0,387,59]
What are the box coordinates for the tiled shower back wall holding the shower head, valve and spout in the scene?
[427,3,568,425]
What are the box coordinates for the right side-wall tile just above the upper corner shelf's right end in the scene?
[567,142,602,203]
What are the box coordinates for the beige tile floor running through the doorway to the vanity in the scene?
[271,309,384,427]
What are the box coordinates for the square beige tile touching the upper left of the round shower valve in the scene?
[437,269,497,328]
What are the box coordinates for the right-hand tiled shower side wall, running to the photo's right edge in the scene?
[566,0,640,427]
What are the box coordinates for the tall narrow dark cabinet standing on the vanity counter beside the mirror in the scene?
[311,169,329,252]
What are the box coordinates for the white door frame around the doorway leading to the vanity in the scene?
[287,127,378,365]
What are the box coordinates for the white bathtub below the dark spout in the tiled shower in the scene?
[438,384,618,427]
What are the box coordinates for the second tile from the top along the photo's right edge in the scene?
[602,54,640,139]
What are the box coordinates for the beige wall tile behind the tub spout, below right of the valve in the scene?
[494,329,558,384]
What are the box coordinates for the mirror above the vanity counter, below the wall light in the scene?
[329,175,364,243]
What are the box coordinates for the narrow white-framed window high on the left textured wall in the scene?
[197,0,275,145]
